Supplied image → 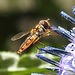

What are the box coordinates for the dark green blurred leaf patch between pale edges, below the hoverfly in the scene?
[18,55,42,68]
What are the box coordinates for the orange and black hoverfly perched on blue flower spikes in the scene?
[11,19,58,53]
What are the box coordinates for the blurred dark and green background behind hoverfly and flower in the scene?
[0,0,75,75]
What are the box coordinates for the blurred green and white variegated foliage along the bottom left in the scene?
[0,52,58,75]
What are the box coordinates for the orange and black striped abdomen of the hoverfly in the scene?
[18,35,37,53]
